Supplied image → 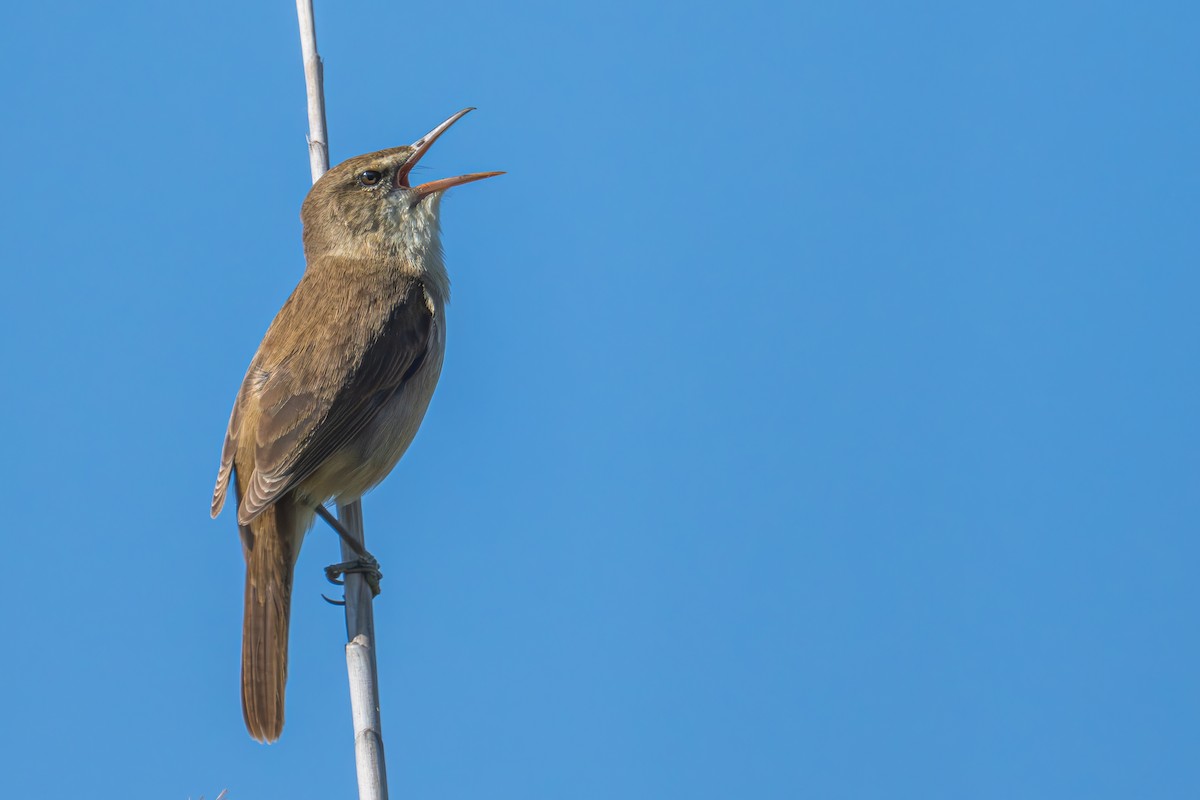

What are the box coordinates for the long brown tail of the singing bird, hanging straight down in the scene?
[241,497,304,742]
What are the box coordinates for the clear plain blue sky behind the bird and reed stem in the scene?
[0,0,1200,800]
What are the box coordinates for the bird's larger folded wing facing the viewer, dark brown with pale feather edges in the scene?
[223,281,434,524]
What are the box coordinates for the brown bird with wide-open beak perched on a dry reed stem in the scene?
[212,108,503,742]
